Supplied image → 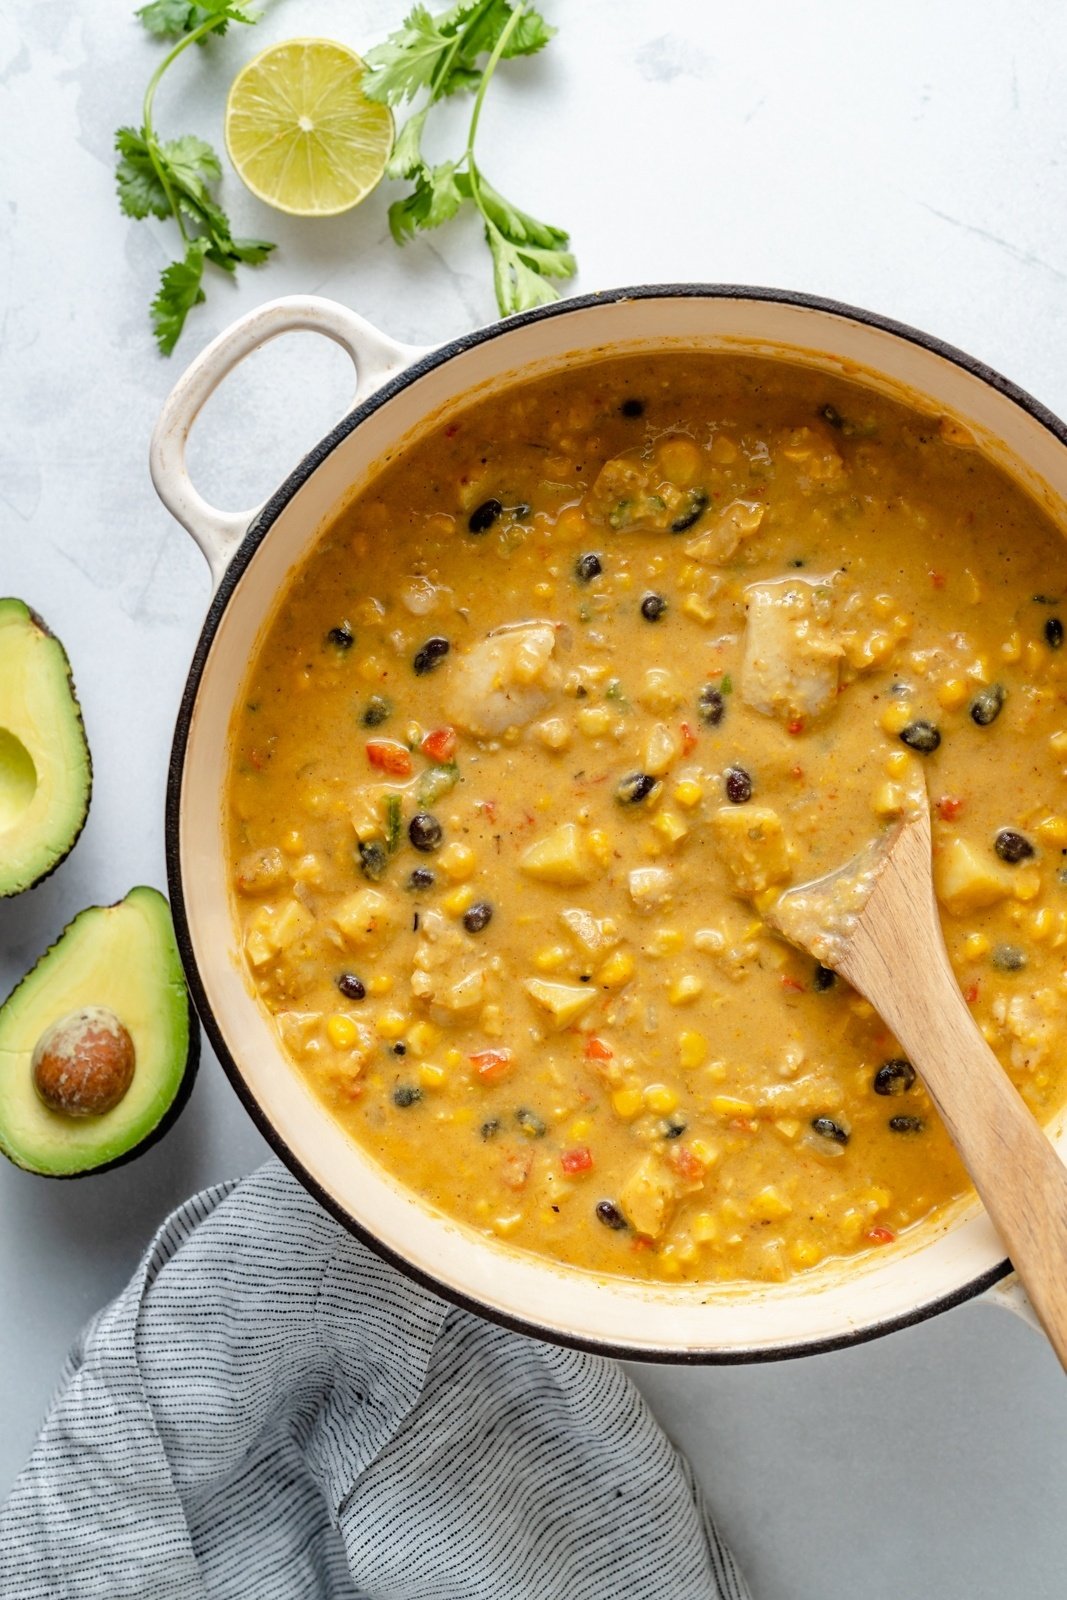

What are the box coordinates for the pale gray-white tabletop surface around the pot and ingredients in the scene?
[0,0,1067,1600]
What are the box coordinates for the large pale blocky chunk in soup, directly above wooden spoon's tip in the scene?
[741,578,843,720]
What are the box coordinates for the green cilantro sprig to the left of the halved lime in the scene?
[115,0,274,355]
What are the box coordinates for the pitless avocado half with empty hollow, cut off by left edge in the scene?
[0,600,93,898]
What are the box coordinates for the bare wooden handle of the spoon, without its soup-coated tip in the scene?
[841,875,1067,1370]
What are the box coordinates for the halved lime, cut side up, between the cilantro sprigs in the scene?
[226,38,394,216]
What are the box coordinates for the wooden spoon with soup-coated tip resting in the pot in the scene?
[766,794,1067,1370]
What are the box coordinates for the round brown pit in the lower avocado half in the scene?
[32,1005,136,1117]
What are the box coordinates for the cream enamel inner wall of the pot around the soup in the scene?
[179,294,1067,1360]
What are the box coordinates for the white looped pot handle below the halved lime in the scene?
[149,294,426,587]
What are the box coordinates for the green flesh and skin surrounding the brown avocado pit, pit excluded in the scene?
[0,888,200,1178]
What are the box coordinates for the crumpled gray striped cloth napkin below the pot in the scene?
[0,1162,747,1600]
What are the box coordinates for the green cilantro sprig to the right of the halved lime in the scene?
[363,0,577,315]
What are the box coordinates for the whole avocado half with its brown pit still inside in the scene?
[0,888,200,1178]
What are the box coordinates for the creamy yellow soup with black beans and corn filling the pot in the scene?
[229,355,1067,1282]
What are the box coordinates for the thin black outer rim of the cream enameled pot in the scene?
[165,283,1067,1366]
